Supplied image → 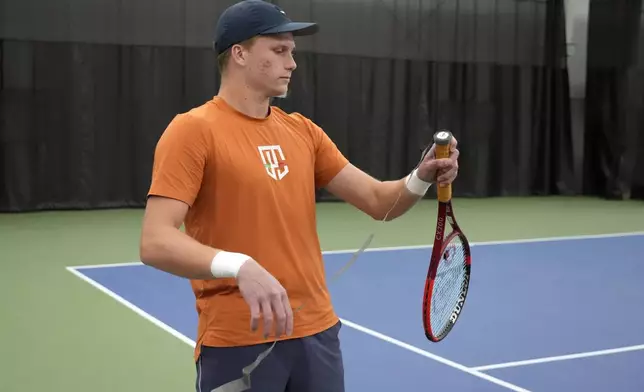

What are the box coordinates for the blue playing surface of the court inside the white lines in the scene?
[68,234,644,392]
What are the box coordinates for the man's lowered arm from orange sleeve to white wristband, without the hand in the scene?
[139,115,249,279]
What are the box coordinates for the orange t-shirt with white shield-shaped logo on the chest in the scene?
[149,97,348,357]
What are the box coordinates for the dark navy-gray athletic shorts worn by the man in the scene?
[196,322,344,392]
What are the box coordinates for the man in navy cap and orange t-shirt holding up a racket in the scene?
[140,0,459,392]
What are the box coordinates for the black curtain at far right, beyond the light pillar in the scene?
[584,0,644,199]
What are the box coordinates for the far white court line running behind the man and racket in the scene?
[66,231,644,269]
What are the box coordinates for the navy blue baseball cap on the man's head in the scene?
[213,0,319,54]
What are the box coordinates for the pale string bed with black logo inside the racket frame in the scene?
[430,236,467,335]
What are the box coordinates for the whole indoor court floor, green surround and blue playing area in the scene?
[0,198,644,392]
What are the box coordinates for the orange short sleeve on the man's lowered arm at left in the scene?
[148,113,208,206]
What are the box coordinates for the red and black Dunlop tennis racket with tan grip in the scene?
[423,131,471,342]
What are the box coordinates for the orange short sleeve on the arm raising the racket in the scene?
[309,121,349,188]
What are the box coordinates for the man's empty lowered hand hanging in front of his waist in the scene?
[237,259,293,338]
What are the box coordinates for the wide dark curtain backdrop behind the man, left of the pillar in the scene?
[0,0,575,211]
